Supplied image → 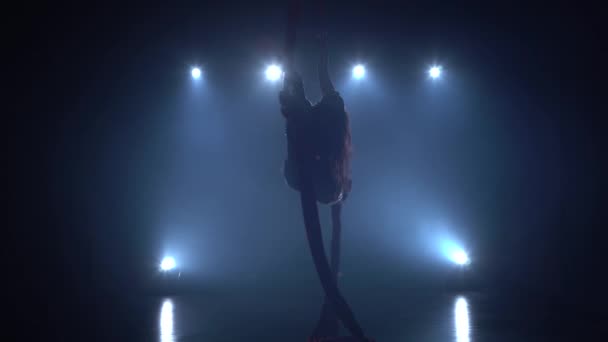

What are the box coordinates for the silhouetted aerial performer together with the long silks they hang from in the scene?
[279,1,367,341]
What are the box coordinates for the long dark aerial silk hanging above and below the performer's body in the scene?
[284,0,365,341]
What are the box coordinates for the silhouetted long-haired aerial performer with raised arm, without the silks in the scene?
[279,36,351,207]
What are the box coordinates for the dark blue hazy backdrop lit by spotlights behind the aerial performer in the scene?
[5,1,607,339]
